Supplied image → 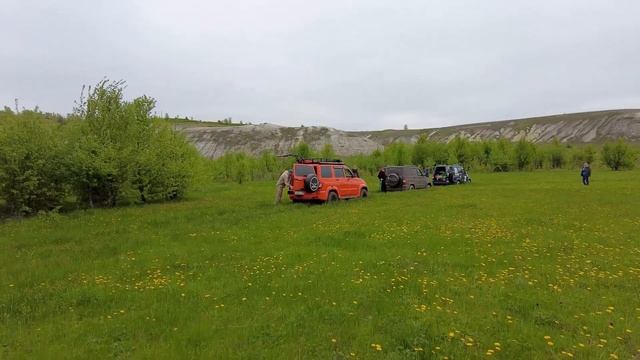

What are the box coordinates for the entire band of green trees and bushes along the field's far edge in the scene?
[0,80,638,216]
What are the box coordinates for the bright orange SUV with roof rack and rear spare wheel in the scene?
[288,159,369,202]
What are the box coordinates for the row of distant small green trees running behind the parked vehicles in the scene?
[210,136,638,183]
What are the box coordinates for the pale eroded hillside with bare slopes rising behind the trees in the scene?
[178,109,640,158]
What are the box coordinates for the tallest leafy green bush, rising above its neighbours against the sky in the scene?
[71,80,196,207]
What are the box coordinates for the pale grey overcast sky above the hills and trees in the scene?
[0,0,640,130]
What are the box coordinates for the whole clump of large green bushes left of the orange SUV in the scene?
[0,80,198,216]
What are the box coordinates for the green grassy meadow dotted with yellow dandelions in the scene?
[0,171,640,359]
